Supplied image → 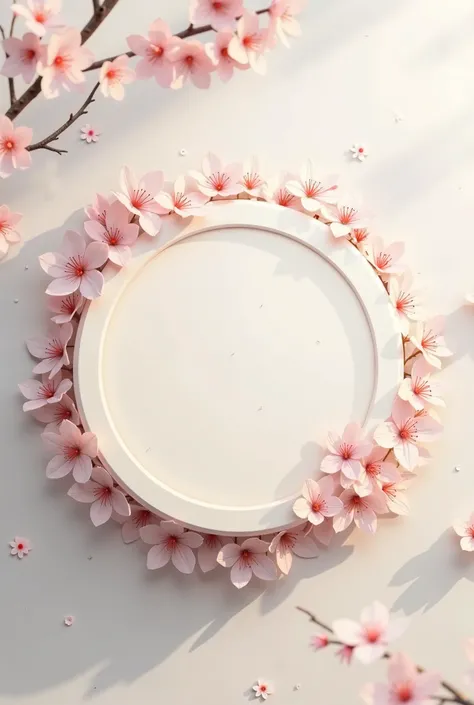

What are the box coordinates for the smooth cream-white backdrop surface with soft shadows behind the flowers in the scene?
[0,0,474,705]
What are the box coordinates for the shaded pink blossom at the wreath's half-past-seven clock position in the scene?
[68,465,130,526]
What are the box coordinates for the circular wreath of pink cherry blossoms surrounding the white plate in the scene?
[19,154,451,588]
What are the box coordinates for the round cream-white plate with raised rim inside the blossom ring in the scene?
[74,201,403,535]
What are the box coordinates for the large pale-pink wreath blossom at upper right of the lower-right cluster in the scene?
[374,398,442,470]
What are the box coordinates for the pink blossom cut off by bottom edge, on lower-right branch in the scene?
[361,654,441,705]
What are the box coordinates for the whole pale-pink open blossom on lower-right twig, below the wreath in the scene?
[332,602,408,663]
